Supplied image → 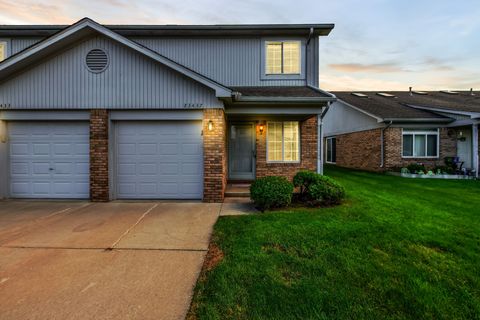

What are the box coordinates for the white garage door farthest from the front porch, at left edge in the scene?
[8,122,89,199]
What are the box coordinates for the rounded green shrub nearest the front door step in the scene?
[250,176,293,212]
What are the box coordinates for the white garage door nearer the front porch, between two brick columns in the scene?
[115,121,203,199]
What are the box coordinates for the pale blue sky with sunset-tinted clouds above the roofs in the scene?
[0,0,480,91]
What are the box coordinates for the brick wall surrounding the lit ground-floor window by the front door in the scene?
[256,116,317,181]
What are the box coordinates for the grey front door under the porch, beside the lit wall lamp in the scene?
[228,123,255,180]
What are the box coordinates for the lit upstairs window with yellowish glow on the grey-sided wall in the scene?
[265,41,301,74]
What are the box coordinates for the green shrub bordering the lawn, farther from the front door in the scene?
[293,170,345,205]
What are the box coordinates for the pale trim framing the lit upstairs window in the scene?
[260,38,306,80]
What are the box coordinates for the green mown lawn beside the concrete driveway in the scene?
[189,167,480,319]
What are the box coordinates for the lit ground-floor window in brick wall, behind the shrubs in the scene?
[267,121,300,162]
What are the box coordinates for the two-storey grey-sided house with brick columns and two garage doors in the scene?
[0,18,335,202]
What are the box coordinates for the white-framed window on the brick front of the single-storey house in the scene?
[402,129,439,158]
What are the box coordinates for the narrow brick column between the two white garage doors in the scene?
[90,109,110,201]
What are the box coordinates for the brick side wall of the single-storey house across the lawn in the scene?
[325,129,381,171]
